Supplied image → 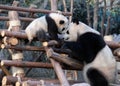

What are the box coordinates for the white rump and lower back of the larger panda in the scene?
[84,45,116,82]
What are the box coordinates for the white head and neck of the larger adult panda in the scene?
[62,21,100,41]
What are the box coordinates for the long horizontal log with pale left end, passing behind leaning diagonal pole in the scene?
[1,60,82,70]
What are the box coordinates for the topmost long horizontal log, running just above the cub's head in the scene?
[0,5,71,16]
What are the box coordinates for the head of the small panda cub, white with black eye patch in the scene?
[49,13,68,33]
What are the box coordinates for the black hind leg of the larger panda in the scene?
[86,68,109,86]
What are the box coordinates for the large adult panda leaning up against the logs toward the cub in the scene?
[62,22,116,86]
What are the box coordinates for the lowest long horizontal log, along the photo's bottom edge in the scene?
[2,76,82,86]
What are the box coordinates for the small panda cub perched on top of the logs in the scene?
[25,13,68,42]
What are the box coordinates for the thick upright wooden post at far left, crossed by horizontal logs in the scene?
[8,1,24,77]
